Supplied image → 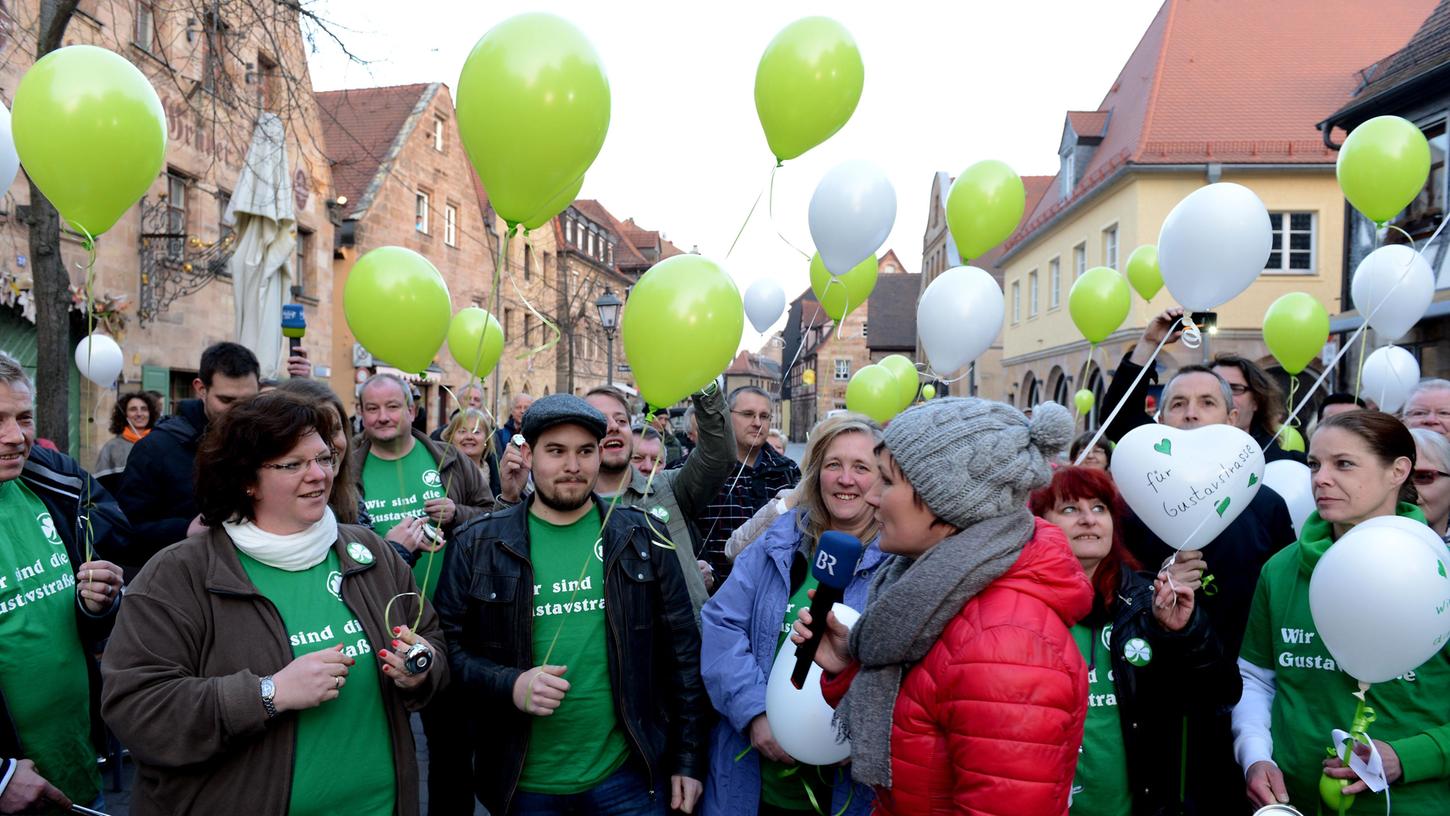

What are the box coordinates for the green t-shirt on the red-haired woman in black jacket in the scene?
[1070,623,1132,816]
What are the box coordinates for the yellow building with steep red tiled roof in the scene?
[996,0,1436,423]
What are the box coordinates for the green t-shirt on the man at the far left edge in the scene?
[0,478,100,803]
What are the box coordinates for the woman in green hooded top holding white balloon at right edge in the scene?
[1234,410,1450,816]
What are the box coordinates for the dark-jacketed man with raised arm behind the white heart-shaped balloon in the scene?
[1102,309,1296,813]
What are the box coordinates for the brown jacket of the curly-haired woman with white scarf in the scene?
[102,525,448,816]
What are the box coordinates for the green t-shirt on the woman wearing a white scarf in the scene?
[236,551,394,816]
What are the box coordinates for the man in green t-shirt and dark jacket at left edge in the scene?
[0,352,129,813]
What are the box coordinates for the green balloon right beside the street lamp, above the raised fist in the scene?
[619,255,745,407]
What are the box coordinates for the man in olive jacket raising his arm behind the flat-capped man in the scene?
[584,383,735,617]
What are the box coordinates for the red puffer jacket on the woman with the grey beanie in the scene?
[821,519,1092,816]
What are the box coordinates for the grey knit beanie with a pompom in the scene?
[885,397,1073,528]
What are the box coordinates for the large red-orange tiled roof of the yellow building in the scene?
[1005,0,1436,251]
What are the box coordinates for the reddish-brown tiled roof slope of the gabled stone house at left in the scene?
[316,83,439,217]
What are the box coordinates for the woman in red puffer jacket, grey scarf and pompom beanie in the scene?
[794,397,1092,816]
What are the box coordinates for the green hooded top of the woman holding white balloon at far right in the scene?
[1240,513,1450,816]
